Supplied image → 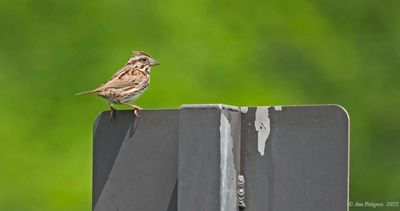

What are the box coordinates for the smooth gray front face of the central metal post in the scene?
[178,109,221,211]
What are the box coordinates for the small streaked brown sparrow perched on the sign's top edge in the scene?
[76,51,160,119]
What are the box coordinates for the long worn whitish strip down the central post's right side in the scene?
[219,113,237,211]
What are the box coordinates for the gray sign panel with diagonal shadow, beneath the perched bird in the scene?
[93,110,178,211]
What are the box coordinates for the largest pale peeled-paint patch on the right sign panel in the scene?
[254,106,271,156]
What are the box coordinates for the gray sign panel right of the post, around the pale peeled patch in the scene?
[242,106,349,211]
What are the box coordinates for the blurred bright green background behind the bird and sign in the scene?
[0,0,400,211]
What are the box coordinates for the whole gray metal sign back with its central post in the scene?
[93,105,349,211]
